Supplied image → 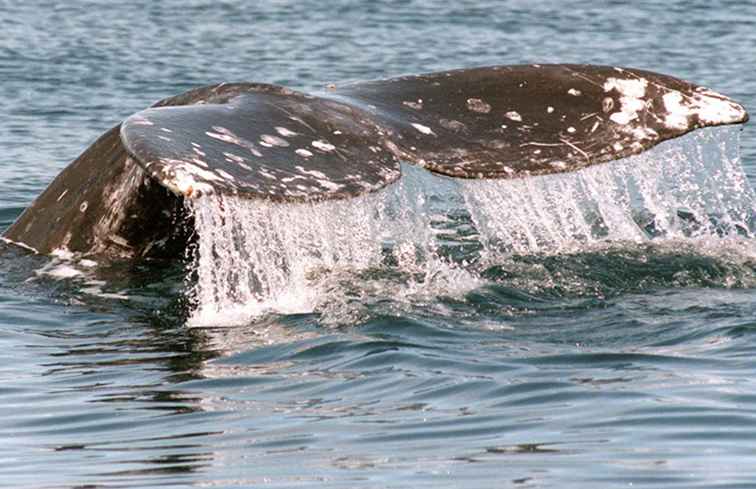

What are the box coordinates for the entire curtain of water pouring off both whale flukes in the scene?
[190,129,754,325]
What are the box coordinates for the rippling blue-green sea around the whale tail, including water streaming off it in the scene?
[0,0,756,488]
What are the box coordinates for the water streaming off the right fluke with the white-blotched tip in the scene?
[463,128,755,261]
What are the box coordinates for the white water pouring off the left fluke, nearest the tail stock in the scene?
[189,168,477,325]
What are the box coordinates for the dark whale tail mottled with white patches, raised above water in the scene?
[5,64,748,257]
